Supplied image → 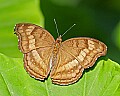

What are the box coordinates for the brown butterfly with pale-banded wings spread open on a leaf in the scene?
[14,23,107,85]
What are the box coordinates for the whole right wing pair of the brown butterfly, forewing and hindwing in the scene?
[50,38,107,85]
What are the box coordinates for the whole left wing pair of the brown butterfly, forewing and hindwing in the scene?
[15,23,55,80]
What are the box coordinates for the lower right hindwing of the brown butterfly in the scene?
[50,48,84,85]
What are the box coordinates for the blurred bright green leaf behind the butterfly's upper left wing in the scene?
[0,0,44,57]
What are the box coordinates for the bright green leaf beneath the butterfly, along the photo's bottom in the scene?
[0,54,120,96]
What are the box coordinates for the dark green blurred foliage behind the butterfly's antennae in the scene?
[40,0,120,63]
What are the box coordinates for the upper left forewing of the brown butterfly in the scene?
[15,23,55,53]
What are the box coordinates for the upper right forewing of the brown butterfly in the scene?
[62,37,107,68]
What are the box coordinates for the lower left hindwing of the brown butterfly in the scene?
[24,47,52,80]
